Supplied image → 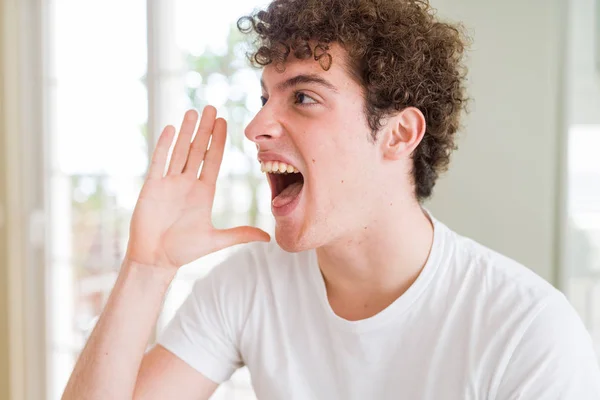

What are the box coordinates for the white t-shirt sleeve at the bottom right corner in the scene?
[496,294,600,400]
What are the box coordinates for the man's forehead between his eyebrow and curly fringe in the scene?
[262,43,353,90]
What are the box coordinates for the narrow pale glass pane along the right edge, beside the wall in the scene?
[563,0,600,359]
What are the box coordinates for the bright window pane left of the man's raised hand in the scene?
[45,0,148,399]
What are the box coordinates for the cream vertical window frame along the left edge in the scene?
[0,0,47,400]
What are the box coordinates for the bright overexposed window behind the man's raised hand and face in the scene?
[43,0,272,400]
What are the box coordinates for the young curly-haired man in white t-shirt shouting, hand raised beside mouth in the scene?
[64,0,600,400]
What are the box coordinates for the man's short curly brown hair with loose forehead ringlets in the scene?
[238,0,468,201]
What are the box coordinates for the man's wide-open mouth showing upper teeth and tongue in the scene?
[261,161,304,208]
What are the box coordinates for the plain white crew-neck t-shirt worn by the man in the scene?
[159,220,600,400]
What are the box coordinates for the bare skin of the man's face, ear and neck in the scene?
[246,45,433,320]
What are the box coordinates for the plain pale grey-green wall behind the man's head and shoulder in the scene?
[428,0,565,281]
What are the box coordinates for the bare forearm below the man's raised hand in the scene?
[63,261,175,400]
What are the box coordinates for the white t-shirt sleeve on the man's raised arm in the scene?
[158,249,257,383]
